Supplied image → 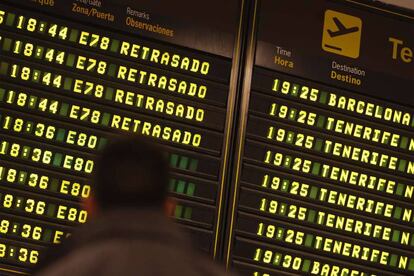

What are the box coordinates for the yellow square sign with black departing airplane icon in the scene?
[322,10,362,58]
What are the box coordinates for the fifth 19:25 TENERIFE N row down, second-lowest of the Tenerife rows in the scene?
[239,185,414,250]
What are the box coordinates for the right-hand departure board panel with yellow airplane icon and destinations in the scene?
[225,0,414,276]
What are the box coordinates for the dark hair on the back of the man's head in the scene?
[93,136,168,210]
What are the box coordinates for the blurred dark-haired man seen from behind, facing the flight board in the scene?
[36,137,231,276]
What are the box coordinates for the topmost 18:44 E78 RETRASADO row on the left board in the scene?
[0,6,230,82]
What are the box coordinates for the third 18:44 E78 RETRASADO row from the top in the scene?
[3,39,225,129]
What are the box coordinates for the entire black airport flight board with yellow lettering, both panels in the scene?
[0,0,414,276]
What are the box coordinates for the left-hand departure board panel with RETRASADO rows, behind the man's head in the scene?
[0,0,240,275]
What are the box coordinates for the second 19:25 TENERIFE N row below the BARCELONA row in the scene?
[246,116,414,176]
